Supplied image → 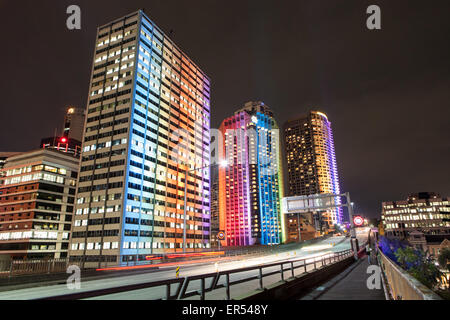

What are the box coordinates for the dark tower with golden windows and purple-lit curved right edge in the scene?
[284,111,342,238]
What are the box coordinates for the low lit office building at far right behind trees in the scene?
[381,192,450,239]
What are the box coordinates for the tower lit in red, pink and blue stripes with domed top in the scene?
[219,102,284,246]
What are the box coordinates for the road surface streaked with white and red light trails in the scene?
[0,234,365,300]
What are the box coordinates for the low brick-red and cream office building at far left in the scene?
[0,149,79,259]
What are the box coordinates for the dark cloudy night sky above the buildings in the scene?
[0,0,450,217]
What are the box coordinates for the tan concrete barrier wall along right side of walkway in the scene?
[378,250,443,300]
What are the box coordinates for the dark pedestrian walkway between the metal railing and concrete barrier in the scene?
[302,256,386,300]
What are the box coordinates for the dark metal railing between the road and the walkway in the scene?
[38,250,353,300]
